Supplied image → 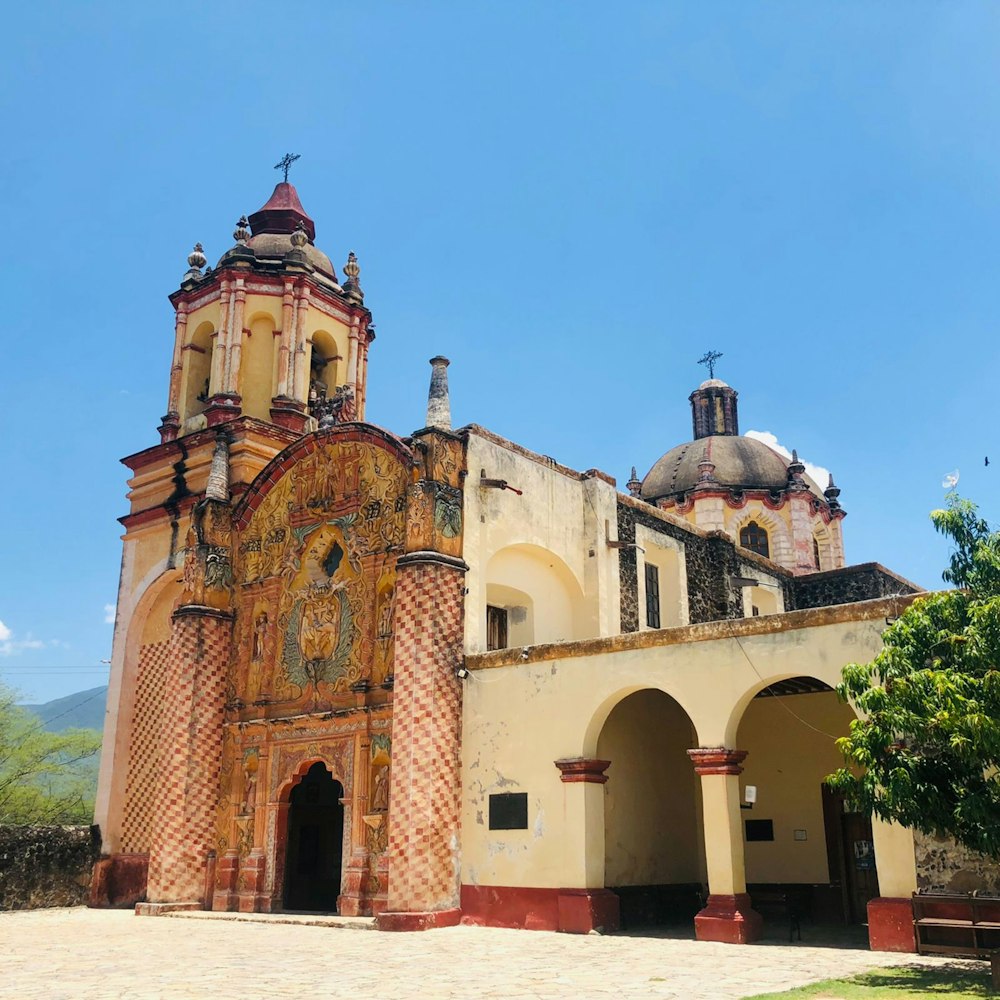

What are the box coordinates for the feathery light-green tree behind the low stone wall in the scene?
[0,686,101,824]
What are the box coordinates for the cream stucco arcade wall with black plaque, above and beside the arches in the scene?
[462,606,892,887]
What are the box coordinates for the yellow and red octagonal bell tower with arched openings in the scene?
[160,170,375,442]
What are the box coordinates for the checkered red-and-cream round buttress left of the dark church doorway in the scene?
[147,608,232,903]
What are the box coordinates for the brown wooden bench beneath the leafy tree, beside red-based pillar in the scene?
[913,892,1000,958]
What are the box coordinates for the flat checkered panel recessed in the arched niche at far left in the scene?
[122,642,170,854]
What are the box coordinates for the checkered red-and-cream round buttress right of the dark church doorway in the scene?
[388,562,465,913]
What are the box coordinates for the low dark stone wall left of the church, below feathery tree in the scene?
[0,826,100,910]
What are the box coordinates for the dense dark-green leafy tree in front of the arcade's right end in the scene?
[828,493,1000,857]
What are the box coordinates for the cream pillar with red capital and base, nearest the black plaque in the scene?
[554,757,621,934]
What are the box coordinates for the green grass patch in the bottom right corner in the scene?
[748,965,1000,1000]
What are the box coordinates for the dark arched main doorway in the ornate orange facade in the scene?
[283,761,344,912]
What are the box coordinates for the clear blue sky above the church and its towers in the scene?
[0,0,1000,699]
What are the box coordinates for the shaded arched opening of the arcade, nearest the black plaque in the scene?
[597,688,706,931]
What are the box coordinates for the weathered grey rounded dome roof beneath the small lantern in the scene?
[639,434,823,501]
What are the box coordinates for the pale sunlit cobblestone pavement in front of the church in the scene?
[0,908,986,1000]
